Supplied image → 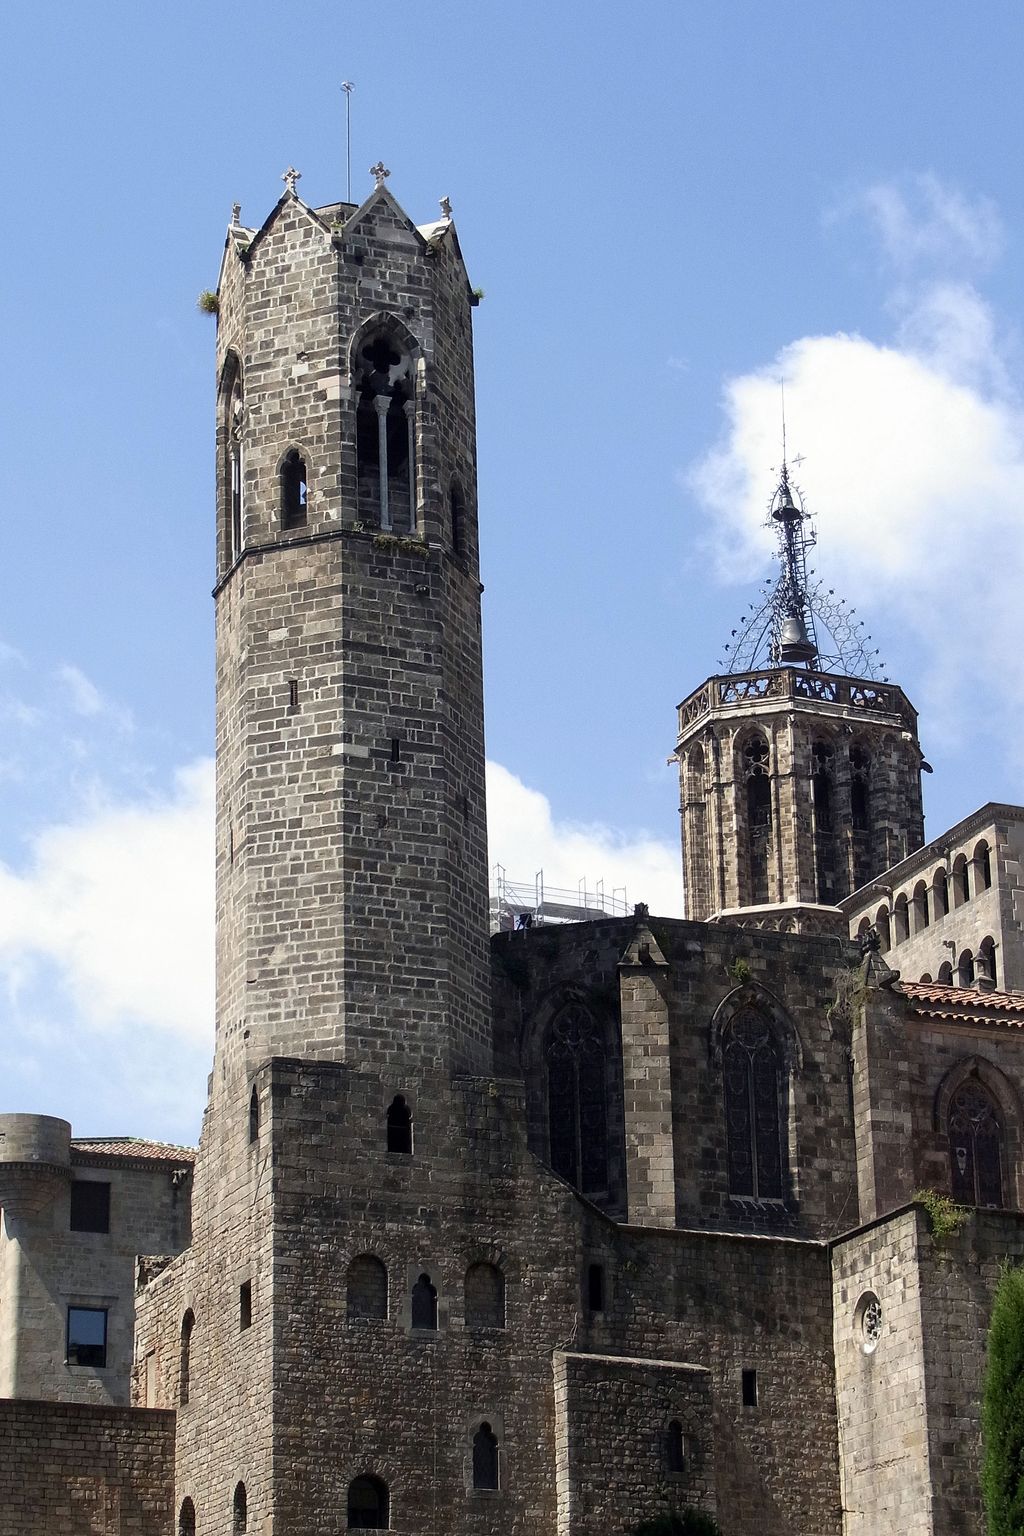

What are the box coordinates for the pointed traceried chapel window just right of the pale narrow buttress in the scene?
[722,1008,785,1200]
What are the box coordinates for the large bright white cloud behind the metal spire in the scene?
[689,254,1024,756]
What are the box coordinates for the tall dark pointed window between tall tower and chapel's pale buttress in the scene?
[547,1003,608,1195]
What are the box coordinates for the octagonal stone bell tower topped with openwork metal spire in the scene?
[674,462,926,935]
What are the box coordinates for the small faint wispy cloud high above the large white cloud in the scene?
[846,172,1003,270]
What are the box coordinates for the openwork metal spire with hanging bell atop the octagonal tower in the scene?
[722,445,887,680]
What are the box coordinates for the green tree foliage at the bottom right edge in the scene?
[981,1266,1024,1536]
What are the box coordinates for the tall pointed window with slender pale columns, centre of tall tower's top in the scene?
[355,330,416,533]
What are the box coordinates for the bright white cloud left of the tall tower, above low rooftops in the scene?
[0,760,213,1041]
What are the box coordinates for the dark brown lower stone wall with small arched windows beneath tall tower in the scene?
[262,1060,838,1536]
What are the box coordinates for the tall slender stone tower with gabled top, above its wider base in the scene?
[215,170,490,1092]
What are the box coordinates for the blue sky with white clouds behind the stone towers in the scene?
[0,0,1024,1140]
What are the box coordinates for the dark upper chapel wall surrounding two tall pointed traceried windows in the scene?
[493,917,857,1236]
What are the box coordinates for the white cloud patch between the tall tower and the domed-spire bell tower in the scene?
[487,762,683,917]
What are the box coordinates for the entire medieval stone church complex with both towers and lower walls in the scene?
[0,167,1024,1536]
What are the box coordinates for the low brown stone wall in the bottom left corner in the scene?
[0,1401,173,1536]
